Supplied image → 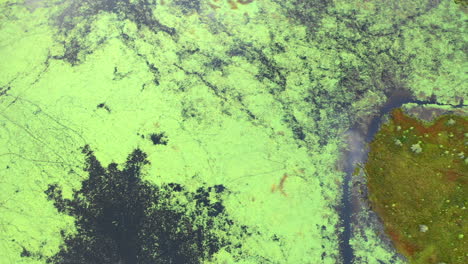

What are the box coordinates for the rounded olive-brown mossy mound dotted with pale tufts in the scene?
[365,109,468,264]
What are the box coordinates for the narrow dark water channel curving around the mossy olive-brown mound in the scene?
[340,90,468,264]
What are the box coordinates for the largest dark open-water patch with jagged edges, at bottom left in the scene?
[27,146,243,264]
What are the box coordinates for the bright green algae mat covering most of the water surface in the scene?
[0,1,467,263]
